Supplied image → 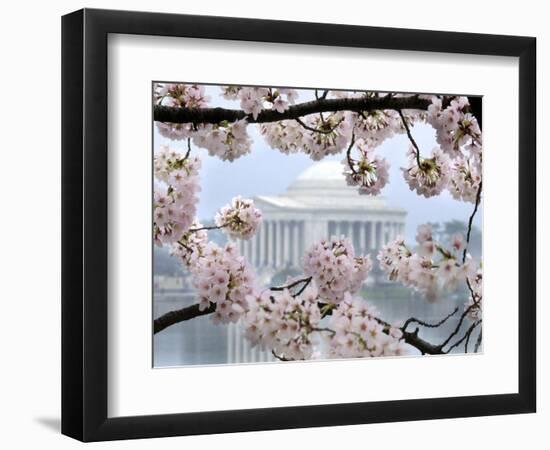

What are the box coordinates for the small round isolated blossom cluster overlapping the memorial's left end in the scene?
[215,195,262,240]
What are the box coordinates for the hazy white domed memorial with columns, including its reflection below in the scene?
[227,160,407,363]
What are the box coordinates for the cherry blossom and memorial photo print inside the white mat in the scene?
[151,81,483,368]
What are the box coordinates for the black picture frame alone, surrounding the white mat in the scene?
[62,9,536,441]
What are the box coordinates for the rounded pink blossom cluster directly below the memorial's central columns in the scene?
[304,238,372,303]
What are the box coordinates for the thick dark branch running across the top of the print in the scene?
[154,95,431,124]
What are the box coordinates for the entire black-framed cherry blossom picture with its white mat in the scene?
[62,9,536,441]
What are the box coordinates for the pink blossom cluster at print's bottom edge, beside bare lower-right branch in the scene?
[329,292,409,358]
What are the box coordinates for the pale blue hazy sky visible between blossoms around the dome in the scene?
[154,87,482,240]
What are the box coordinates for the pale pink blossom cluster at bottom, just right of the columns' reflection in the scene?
[243,285,321,360]
